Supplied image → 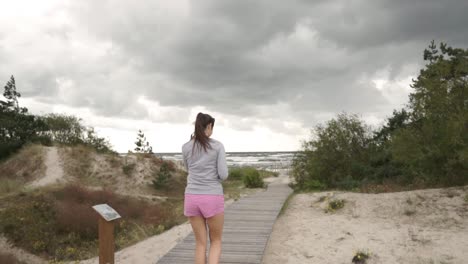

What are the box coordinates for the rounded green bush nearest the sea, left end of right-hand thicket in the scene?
[292,113,373,190]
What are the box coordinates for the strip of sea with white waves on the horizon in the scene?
[155,152,296,171]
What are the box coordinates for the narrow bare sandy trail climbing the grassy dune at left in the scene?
[30,147,63,187]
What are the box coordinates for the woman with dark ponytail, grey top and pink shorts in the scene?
[182,113,228,264]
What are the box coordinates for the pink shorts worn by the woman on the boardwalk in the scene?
[184,193,224,218]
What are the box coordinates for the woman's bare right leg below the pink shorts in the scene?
[206,213,224,264]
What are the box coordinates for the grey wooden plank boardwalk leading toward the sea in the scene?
[157,182,292,264]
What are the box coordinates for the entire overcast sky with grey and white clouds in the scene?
[0,0,468,152]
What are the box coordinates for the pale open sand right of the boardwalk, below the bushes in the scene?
[263,186,468,264]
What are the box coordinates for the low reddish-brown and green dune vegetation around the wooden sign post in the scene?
[0,184,185,261]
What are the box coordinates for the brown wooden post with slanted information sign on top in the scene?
[93,204,120,264]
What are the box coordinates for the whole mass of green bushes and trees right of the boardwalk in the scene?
[292,42,468,192]
